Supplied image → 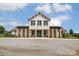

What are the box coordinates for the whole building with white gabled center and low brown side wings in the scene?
[11,12,64,38]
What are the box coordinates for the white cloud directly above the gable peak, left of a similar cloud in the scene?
[35,4,52,14]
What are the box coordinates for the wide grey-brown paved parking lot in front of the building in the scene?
[0,38,79,56]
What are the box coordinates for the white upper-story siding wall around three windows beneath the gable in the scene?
[29,15,49,29]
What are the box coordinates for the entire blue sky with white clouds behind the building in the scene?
[0,3,79,33]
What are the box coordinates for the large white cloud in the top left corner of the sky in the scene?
[0,3,28,11]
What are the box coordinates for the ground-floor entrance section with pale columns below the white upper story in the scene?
[29,29,49,37]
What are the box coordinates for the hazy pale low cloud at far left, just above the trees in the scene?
[0,17,24,30]
